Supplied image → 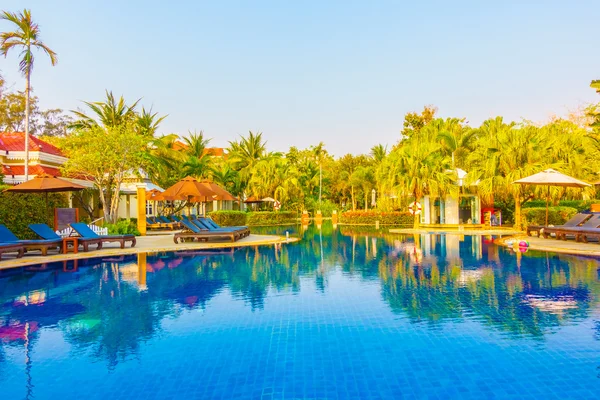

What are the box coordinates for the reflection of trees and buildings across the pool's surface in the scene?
[0,223,600,369]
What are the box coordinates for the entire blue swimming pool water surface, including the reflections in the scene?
[0,225,600,400]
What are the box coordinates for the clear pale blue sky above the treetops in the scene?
[0,0,600,156]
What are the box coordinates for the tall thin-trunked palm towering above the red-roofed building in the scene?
[0,9,58,180]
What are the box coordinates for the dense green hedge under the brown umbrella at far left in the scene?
[0,190,68,239]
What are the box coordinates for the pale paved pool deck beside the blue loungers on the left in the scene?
[0,234,299,270]
